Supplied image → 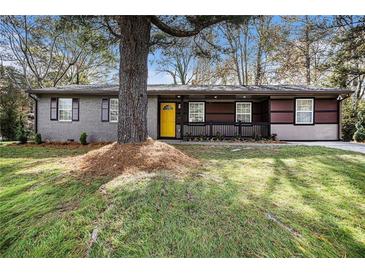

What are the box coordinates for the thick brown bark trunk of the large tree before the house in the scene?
[118,16,151,144]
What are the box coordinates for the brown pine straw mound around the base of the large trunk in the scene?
[68,140,199,177]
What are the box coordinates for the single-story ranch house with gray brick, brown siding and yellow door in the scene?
[28,85,351,142]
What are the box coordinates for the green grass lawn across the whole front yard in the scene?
[0,142,365,257]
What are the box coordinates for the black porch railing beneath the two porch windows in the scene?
[183,122,270,138]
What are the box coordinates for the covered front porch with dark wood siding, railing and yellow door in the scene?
[158,95,271,139]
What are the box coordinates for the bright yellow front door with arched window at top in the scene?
[160,103,176,137]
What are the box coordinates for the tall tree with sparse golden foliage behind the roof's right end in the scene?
[274,16,331,85]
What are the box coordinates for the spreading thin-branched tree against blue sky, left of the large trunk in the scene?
[0,16,116,88]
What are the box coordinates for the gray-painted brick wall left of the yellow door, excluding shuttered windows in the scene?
[37,95,157,142]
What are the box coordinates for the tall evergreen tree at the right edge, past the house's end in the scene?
[327,16,365,140]
